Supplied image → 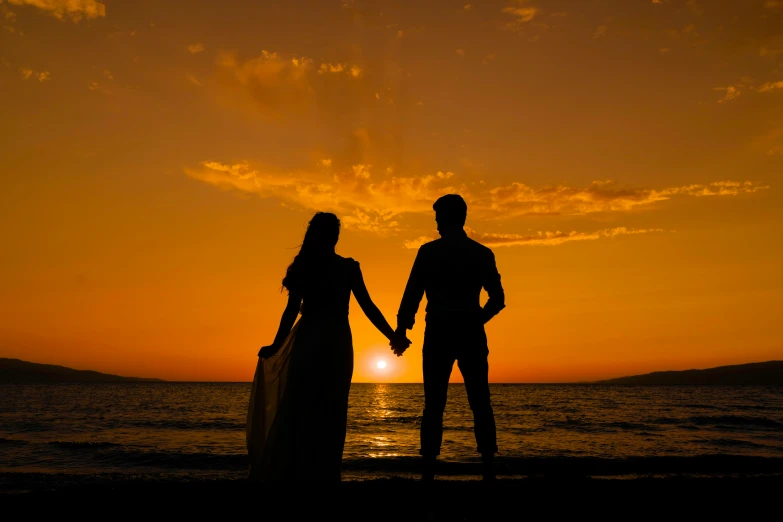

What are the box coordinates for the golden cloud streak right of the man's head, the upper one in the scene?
[489,181,769,216]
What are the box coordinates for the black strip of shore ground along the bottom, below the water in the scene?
[0,473,783,522]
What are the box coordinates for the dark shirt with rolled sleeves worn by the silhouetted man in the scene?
[397,230,506,330]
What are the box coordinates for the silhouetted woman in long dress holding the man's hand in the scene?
[246,212,410,481]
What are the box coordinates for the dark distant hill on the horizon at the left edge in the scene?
[0,358,164,384]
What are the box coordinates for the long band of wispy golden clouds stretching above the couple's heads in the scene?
[185,153,769,237]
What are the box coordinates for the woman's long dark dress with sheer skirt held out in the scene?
[246,255,360,481]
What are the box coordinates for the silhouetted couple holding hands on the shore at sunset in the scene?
[247,194,505,481]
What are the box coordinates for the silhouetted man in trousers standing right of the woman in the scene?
[392,194,505,481]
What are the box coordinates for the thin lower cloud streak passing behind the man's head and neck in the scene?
[403,227,664,249]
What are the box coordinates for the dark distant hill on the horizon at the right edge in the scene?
[595,361,783,385]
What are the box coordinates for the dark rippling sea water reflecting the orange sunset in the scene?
[0,383,783,480]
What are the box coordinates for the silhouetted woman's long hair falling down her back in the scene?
[283,212,340,292]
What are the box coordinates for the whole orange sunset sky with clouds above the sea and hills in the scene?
[0,0,783,382]
